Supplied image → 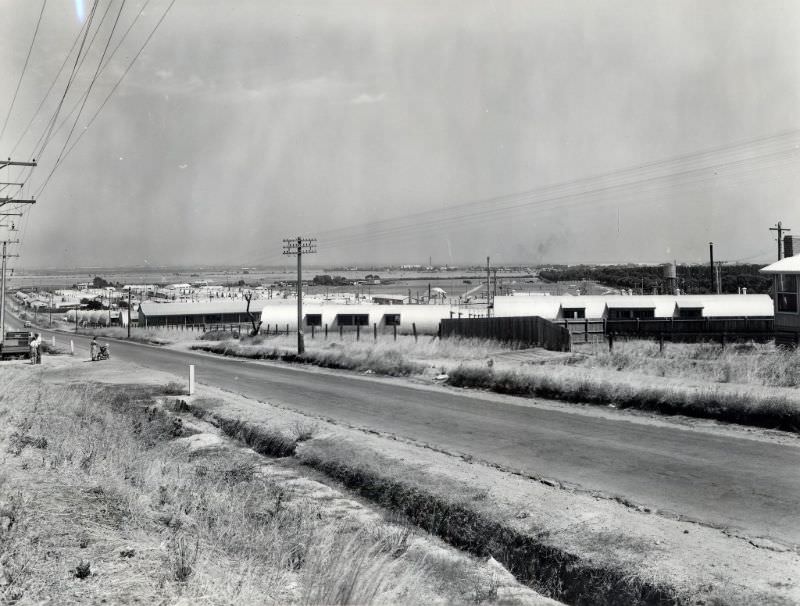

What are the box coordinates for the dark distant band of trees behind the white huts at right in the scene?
[539,264,772,294]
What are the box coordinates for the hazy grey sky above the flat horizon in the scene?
[0,0,800,268]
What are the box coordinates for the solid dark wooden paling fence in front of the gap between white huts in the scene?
[441,316,570,351]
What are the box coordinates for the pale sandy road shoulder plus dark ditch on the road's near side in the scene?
[187,372,800,604]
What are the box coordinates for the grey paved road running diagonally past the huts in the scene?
[12,320,800,546]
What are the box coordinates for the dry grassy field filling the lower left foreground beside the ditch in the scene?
[0,368,524,604]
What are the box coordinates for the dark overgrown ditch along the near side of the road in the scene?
[191,401,677,605]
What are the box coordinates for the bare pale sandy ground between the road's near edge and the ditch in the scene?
[23,358,800,604]
